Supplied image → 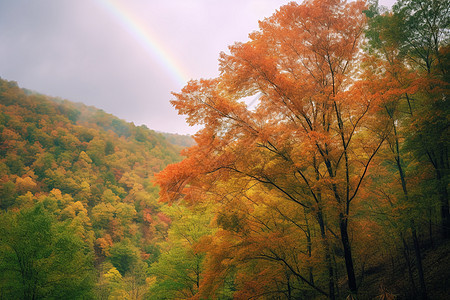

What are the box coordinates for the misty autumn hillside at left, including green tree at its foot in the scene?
[0,80,187,299]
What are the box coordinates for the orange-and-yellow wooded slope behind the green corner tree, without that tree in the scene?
[0,79,181,298]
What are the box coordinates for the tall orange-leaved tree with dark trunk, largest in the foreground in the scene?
[159,0,385,298]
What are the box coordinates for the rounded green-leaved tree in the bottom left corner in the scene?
[0,205,93,299]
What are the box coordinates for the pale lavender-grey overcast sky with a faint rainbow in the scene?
[0,0,394,134]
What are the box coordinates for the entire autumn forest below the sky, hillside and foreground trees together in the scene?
[0,0,450,299]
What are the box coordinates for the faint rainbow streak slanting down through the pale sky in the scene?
[97,0,189,86]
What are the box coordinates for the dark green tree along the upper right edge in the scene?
[390,0,450,238]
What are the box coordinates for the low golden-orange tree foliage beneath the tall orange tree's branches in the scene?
[193,177,329,299]
